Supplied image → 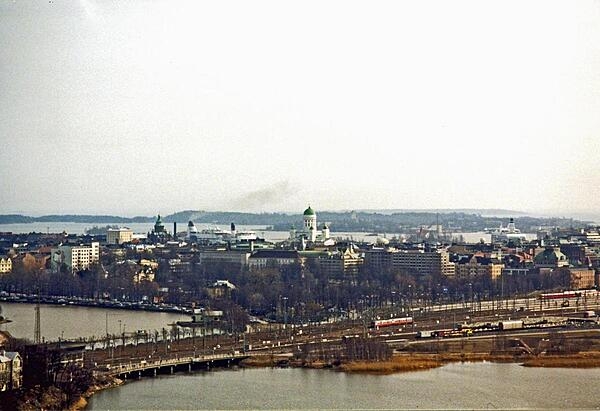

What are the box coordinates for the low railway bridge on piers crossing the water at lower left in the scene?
[94,352,250,379]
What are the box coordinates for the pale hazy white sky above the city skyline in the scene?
[0,0,600,216]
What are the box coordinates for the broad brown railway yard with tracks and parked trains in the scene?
[86,293,600,371]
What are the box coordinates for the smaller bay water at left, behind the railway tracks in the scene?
[0,302,189,341]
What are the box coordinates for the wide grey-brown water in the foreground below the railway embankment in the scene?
[89,363,600,410]
